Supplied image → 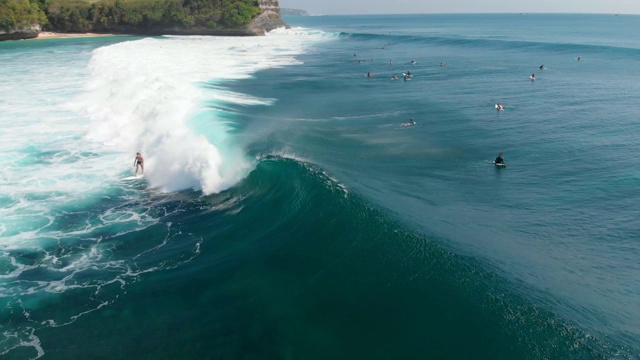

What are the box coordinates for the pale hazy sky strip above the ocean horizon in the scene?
[279,0,640,15]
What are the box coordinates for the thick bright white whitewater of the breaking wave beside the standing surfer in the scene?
[79,29,336,194]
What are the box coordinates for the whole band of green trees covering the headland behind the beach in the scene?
[0,0,260,33]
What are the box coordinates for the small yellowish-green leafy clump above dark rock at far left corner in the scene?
[0,0,47,32]
